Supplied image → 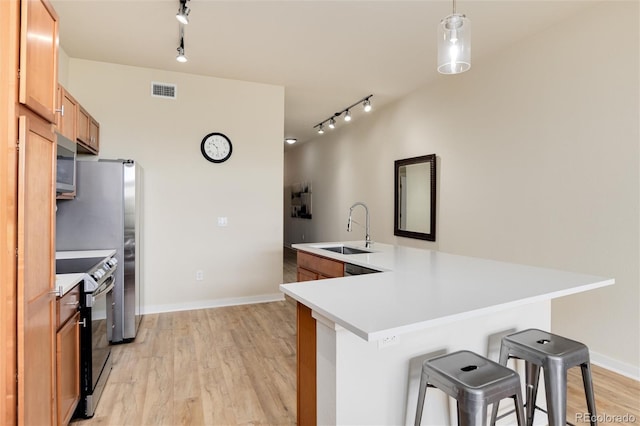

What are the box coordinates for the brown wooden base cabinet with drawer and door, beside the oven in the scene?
[56,285,80,426]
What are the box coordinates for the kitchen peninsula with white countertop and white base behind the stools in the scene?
[280,242,614,425]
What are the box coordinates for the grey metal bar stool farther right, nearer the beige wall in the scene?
[491,329,597,426]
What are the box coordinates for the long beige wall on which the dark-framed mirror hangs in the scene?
[285,2,640,377]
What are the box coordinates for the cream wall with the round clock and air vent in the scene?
[68,58,284,312]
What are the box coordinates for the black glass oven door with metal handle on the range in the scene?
[83,275,115,416]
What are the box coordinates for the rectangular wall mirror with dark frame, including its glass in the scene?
[393,154,436,241]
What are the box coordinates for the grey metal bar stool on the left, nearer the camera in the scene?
[415,351,524,426]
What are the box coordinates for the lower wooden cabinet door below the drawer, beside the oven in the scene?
[56,312,80,426]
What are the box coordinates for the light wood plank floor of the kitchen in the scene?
[72,250,640,426]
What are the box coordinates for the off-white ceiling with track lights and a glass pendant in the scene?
[51,0,593,146]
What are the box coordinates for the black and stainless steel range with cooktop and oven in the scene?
[56,256,118,418]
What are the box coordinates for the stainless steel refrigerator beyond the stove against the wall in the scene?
[56,160,142,343]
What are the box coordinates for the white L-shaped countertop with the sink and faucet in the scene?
[280,241,615,341]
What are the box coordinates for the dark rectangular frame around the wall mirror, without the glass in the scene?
[393,154,436,241]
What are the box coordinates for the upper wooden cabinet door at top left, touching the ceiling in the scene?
[19,0,58,123]
